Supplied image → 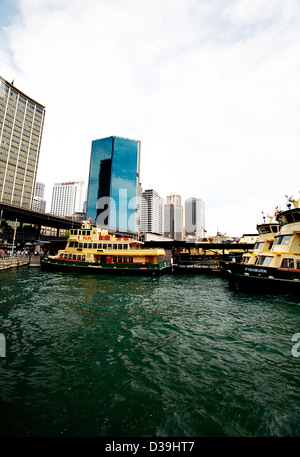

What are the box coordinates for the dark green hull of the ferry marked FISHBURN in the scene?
[221,262,300,295]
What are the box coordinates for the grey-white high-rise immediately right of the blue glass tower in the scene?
[141,189,164,235]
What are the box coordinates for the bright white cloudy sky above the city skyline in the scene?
[0,0,300,236]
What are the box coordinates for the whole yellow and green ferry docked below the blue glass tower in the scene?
[41,221,171,276]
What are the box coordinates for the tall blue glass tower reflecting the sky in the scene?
[87,136,141,232]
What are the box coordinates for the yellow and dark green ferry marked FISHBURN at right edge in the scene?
[221,199,300,293]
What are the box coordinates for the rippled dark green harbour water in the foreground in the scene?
[0,267,300,437]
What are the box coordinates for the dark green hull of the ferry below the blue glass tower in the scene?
[41,259,171,276]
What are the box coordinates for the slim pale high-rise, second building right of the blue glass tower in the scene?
[164,194,183,241]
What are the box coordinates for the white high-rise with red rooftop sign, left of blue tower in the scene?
[50,181,85,217]
